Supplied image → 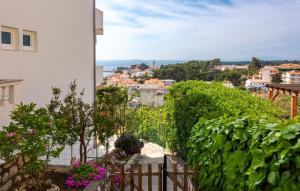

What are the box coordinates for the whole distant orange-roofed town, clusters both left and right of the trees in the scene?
[97,63,300,108]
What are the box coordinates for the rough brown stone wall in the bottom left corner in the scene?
[0,156,29,191]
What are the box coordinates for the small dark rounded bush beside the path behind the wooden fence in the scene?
[115,134,144,155]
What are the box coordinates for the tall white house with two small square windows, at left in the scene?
[0,0,103,107]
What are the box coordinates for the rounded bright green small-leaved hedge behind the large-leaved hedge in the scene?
[166,81,284,159]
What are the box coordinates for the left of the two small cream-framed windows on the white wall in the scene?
[1,26,19,50]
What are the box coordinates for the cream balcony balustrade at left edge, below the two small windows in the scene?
[0,80,22,129]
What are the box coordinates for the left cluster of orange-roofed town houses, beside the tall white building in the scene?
[97,64,176,108]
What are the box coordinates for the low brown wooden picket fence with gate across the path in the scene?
[110,157,199,191]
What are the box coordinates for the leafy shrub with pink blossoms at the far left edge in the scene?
[0,103,67,190]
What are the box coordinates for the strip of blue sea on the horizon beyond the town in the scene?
[96,60,184,77]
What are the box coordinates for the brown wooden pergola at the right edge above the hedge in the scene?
[266,84,300,118]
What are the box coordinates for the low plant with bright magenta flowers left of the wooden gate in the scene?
[65,161,106,188]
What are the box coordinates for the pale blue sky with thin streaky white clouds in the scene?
[96,0,300,61]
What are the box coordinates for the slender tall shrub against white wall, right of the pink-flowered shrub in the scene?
[47,81,95,162]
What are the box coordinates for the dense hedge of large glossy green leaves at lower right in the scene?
[188,117,300,191]
